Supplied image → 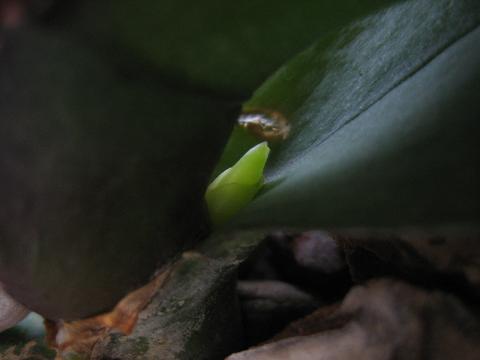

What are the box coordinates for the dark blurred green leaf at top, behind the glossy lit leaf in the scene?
[57,0,398,96]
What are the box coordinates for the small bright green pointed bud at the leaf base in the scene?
[205,142,270,225]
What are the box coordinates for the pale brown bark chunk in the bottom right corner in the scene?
[227,279,480,360]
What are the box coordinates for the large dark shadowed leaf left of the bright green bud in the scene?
[0,29,231,319]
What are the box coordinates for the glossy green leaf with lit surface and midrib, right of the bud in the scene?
[227,0,480,231]
